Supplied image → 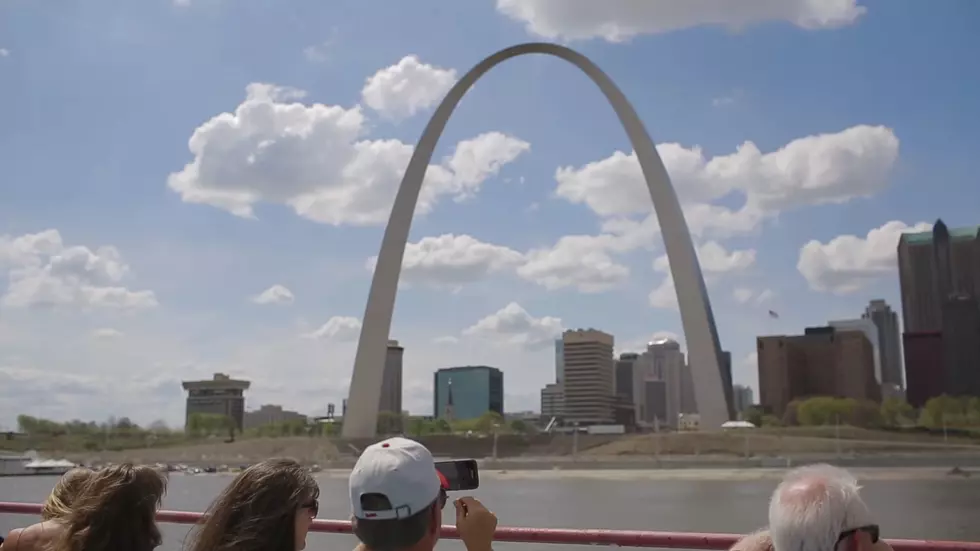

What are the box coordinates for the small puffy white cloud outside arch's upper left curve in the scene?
[361,55,456,119]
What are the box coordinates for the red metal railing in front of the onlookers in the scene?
[0,501,980,551]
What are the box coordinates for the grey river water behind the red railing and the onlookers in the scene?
[0,473,980,551]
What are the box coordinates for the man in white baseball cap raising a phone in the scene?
[350,438,497,551]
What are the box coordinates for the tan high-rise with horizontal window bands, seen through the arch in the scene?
[562,329,615,425]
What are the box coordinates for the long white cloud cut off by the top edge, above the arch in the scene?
[497,0,867,42]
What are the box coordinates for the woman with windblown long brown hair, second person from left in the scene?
[47,464,167,551]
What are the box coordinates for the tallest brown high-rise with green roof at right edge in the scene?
[898,220,980,333]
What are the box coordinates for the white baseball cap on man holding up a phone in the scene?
[350,437,446,520]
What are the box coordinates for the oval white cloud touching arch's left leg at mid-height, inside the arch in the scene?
[367,233,524,287]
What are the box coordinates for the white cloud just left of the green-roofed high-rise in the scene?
[796,220,932,295]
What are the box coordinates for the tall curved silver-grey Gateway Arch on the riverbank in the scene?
[343,43,729,438]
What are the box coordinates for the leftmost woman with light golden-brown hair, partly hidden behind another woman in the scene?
[0,468,93,551]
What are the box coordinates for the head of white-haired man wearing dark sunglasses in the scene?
[769,465,891,551]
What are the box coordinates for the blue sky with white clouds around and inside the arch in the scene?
[0,0,980,425]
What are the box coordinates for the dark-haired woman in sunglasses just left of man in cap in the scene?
[185,459,320,551]
